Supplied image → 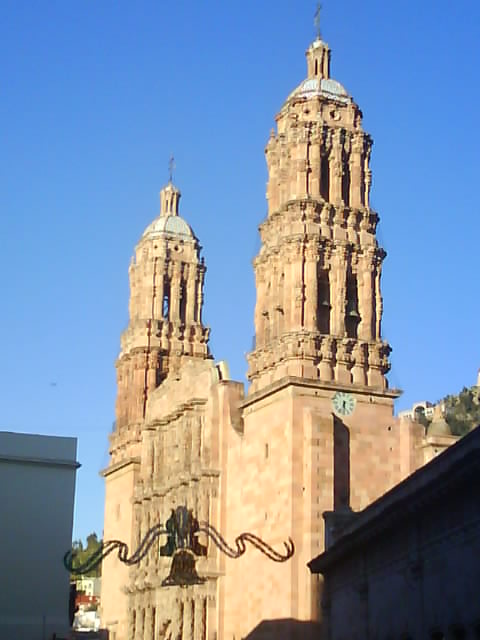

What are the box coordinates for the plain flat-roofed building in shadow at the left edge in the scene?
[0,432,80,640]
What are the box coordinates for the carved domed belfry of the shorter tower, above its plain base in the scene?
[112,181,209,457]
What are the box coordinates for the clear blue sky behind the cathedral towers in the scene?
[0,0,480,537]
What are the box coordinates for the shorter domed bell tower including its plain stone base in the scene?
[102,181,210,638]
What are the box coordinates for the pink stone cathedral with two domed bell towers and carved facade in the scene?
[101,25,454,640]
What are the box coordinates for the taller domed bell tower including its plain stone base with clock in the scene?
[224,38,413,638]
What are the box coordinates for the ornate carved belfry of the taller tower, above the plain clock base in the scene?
[248,39,390,393]
